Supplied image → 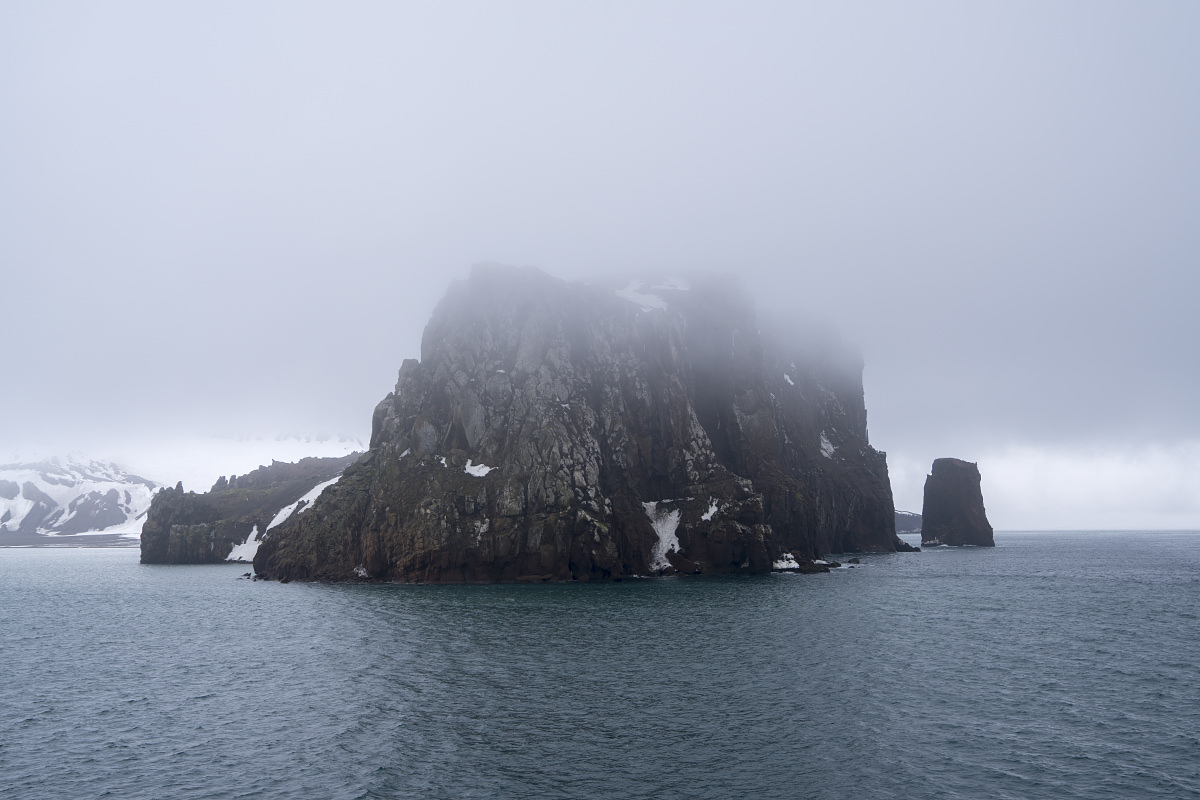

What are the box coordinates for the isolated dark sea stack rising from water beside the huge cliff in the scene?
[920,458,996,547]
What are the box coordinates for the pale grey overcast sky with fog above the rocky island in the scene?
[0,0,1200,529]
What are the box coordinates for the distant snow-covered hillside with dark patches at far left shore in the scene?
[0,458,160,543]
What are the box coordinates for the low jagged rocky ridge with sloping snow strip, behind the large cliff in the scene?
[142,453,361,564]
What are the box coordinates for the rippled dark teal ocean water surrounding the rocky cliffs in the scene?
[0,533,1200,800]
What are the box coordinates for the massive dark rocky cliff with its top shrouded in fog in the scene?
[254,267,900,582]
